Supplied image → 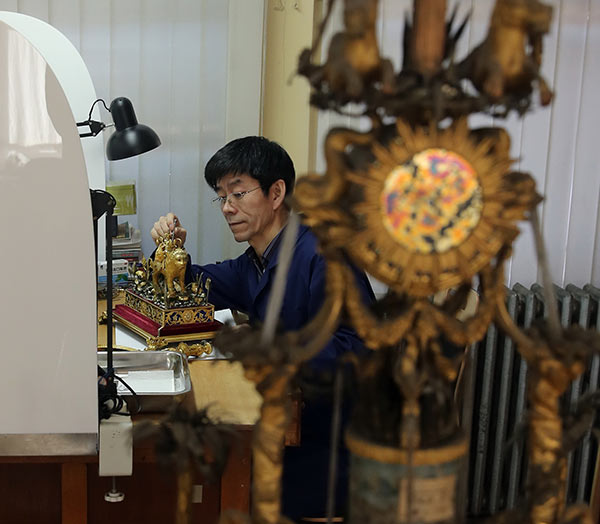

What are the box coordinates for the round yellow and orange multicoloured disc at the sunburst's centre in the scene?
[380,148,483,255]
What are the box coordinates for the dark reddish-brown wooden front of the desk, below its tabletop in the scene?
[0,422,252,524]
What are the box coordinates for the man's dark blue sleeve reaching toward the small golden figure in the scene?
[185,259,249,312]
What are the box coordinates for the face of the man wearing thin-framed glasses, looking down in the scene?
[216,174,275,243]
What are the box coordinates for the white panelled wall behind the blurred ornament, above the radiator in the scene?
[316,0,600,286]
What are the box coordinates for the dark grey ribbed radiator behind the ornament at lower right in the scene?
[463,284,600,517]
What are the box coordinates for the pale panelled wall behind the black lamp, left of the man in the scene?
[0,0,264,262]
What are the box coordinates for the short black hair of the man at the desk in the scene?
[204,136,296,196]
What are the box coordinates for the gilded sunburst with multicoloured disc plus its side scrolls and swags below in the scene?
[295,120,539,349]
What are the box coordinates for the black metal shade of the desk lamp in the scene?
[106,97,160,160]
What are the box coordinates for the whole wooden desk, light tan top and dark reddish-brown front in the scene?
[0,305,300,524]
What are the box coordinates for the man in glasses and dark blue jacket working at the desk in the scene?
[151,137,374,519]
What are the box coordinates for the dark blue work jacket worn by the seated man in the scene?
[187,226,375,520]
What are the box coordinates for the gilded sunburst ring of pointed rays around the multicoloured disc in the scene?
[345,121,524,296]
